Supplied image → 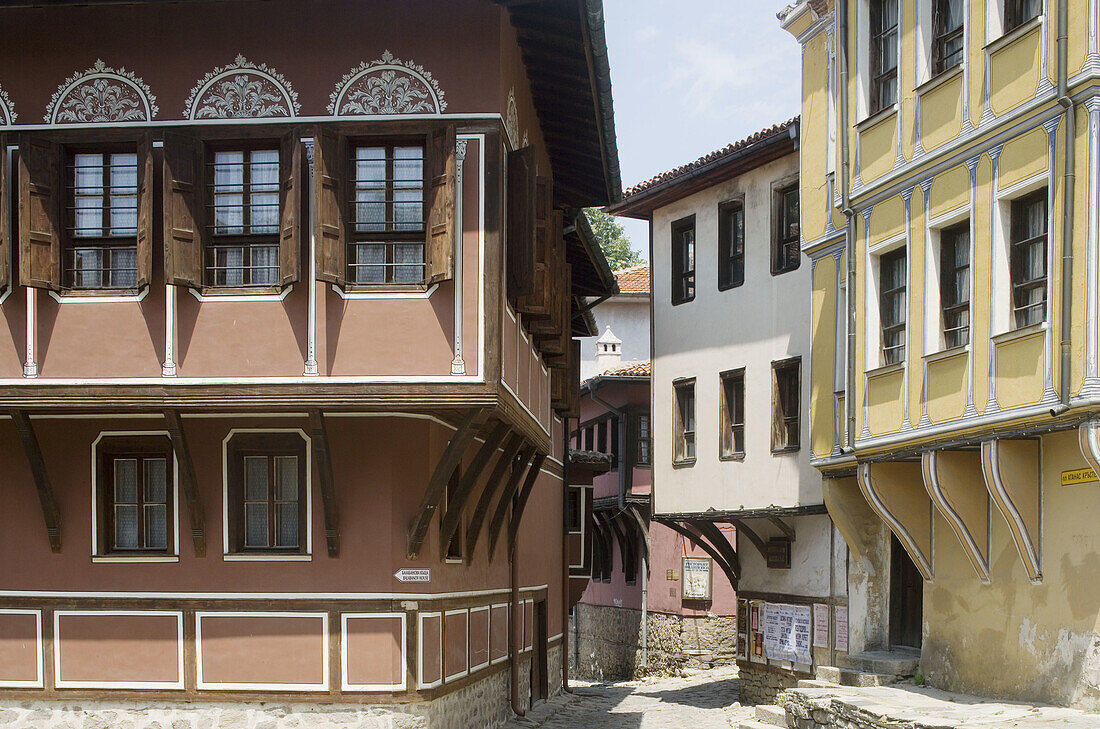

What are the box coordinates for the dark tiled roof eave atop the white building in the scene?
[607,117,800,220]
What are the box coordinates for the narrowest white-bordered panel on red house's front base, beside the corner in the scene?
[340,612,408,691]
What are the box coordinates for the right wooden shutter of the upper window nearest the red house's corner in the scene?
[427,124,453,285]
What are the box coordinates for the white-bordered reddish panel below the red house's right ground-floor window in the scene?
[195,612,329,691]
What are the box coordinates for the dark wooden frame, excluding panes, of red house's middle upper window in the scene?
[202,137,287,291]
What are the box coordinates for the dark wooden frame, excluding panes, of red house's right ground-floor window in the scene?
[226,432,311,555]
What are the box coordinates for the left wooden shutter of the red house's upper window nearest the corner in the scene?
[314,130,349,286]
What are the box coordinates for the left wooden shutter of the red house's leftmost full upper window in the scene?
[19,137,62,290]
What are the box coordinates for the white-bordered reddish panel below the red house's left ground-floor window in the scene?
[54,610,184,688]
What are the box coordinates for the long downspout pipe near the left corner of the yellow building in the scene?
[836,0,856,453]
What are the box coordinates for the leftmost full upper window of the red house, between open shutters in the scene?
[64,151,138,289]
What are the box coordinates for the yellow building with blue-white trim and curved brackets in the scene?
[780,0,1100,708]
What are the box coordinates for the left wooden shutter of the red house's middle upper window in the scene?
[164,132,206,288]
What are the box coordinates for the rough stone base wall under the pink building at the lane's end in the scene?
[569,603,737,681]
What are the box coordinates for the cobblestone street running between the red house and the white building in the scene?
[505,669,752,729]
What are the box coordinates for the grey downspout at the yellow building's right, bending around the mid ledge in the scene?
[1051,0,1077,416]
